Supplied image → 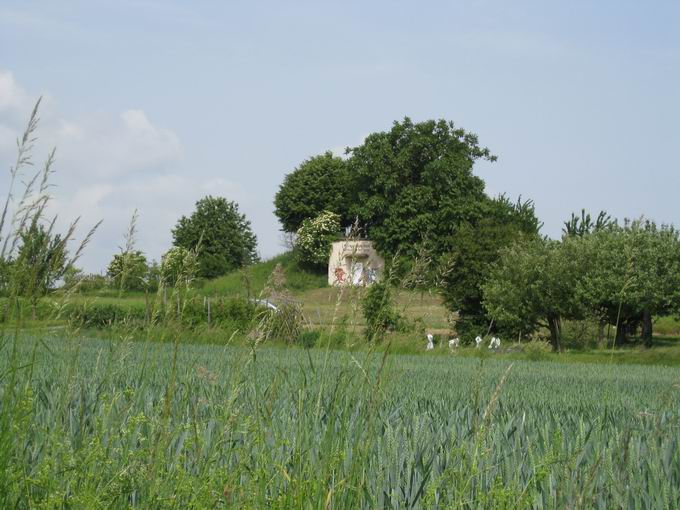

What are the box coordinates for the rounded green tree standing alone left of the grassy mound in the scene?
[172,196,258,278]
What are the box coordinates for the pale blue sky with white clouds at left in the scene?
[0,0,680,272]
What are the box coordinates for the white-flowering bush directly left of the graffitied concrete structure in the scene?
[295,211,340,266]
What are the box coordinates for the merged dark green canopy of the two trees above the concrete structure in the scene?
[274,117,496,256]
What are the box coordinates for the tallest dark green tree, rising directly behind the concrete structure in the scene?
[347,118,496,256]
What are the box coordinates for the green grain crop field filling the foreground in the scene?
[0,334,680,508]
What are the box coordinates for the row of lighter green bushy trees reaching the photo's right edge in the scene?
[483,221,680,350]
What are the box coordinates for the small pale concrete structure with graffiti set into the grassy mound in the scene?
[328,240,385,285]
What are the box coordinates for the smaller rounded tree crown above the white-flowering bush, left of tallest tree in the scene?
[274,152,351,232]
